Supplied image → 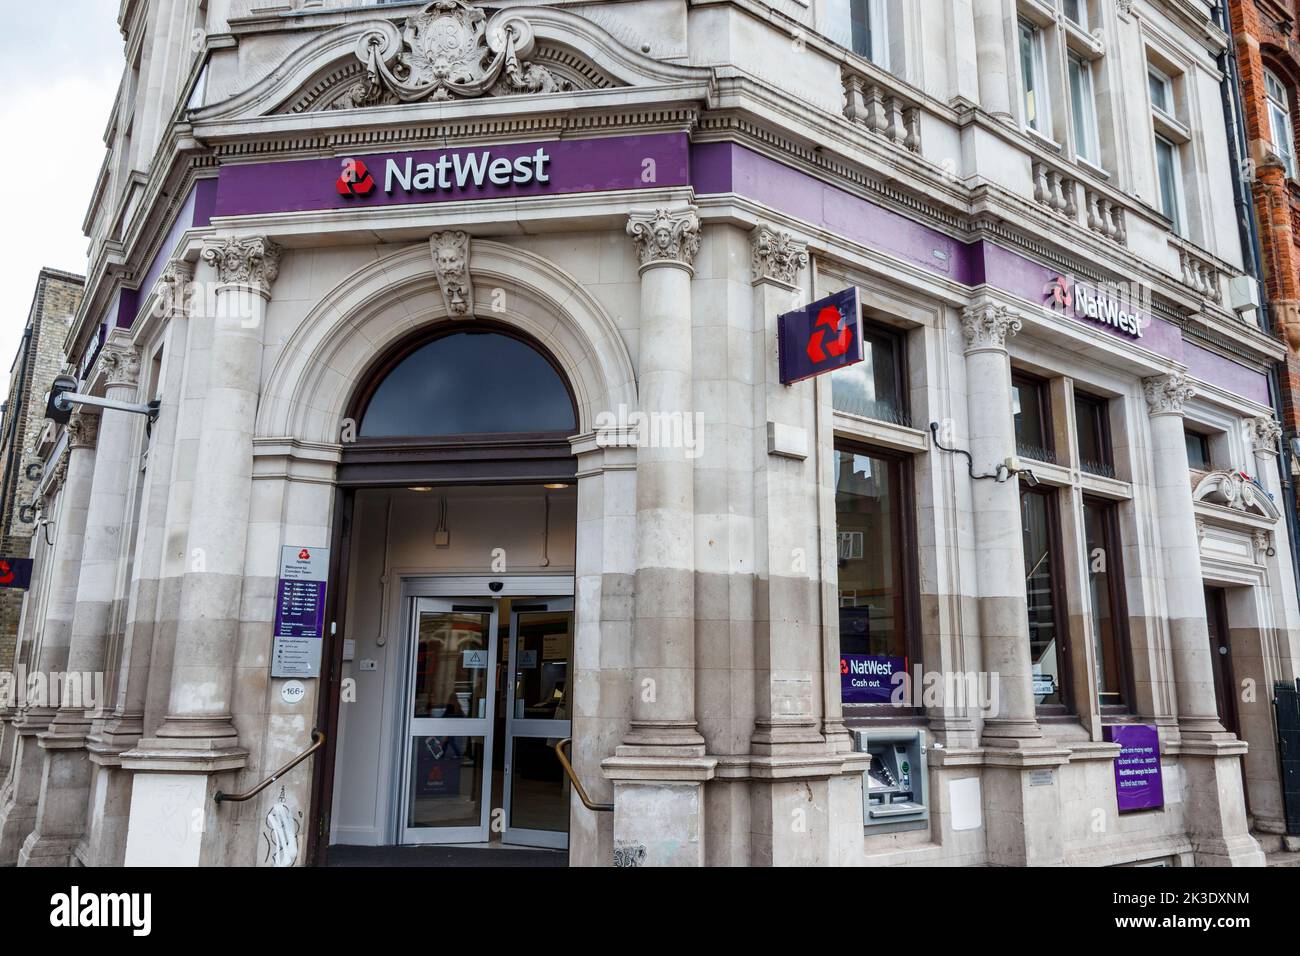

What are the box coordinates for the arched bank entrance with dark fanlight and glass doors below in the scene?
[320,320,579,848]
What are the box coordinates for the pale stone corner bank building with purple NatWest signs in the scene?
[0,0,1300,865]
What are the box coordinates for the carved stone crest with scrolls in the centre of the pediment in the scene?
[340,0,569,109]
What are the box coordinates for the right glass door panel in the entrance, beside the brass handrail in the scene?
[502,597,573,848]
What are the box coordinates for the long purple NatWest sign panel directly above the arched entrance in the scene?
[213,133,690,216]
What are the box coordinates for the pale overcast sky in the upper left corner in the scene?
[0,0,122,382]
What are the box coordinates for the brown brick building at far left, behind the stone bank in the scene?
[0,268,85,672]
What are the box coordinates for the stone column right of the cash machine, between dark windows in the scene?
[962,302,1043,747]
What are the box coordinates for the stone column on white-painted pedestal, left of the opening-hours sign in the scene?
[122,237,281,865]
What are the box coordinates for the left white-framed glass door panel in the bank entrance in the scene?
[399,597,497,843]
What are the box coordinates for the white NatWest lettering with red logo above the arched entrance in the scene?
[335,147,551,198]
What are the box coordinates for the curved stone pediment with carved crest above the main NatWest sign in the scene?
[191,0,712,124]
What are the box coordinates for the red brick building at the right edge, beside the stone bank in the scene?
[1229,0,1300,434]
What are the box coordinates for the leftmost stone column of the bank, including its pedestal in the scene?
[0,411,99,865]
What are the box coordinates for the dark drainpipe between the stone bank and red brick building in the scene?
[1214,0,1300,596]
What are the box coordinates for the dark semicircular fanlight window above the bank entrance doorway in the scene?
[358,326,577,440]
